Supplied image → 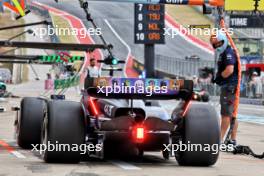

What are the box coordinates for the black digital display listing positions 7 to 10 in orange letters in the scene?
[135,4,165,44]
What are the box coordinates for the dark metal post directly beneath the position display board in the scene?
[145,44,155,78]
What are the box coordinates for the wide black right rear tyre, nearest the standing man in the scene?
[173,104,220,166]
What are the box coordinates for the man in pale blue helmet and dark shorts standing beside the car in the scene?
[210,30,238,146]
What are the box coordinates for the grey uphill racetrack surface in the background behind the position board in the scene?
[37,0,213,61]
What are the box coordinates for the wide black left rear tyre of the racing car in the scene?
[41,100,86,163]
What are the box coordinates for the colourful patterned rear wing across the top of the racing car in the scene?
[85,77,193,100]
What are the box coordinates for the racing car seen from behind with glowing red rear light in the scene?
[16,77,220,166]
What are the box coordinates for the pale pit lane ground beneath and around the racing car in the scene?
[0,81,264,176]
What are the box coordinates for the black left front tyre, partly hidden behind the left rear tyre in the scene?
[17,97,46,149]
